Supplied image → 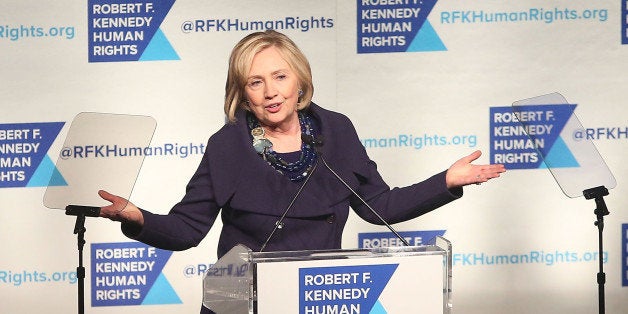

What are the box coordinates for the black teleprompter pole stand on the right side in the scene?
[582,186,610,314]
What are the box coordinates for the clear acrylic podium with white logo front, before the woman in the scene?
[203,237,452,314]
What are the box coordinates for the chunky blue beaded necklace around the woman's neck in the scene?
[246,111,317,181]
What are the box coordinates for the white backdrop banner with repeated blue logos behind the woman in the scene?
[0,0,628,314]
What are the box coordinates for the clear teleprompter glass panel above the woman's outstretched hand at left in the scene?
[43,112,156,209]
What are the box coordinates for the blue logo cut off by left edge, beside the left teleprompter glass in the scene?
[0,122,67,188]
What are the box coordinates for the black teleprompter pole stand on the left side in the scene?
[65,205,100,314]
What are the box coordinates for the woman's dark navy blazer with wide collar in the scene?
[122,104,462,257]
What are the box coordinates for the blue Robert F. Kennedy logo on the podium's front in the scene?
[299,264,398,314]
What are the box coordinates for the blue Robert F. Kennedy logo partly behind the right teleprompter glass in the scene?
[490,104,579,169]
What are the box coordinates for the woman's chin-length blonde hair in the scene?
[225,30,314,123]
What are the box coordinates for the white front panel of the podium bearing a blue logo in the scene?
[255,255,445,314]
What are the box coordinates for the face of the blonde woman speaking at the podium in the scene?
[244,46,299,127]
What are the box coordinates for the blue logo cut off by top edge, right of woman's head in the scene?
[357,0,447,53]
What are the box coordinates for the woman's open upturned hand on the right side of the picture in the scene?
[446,150,506,189]
